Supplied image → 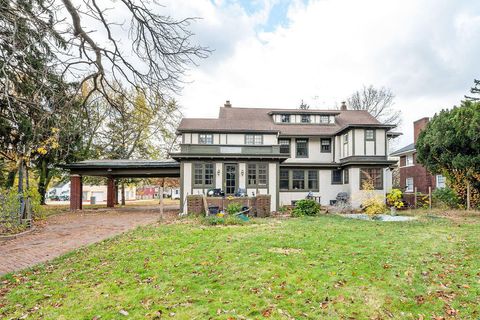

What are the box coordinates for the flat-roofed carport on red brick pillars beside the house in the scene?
[61,159,180,211]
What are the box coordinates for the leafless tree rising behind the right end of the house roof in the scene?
[347,85,401,125]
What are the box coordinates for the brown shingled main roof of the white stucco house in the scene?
[178,107,395,136]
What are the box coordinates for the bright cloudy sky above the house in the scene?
[148,0,480,146]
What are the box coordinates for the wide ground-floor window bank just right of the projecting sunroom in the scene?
[280,169,318,191]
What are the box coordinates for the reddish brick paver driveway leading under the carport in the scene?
[0,206,178,275]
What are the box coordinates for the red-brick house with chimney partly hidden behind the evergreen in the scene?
[391,118,445,204]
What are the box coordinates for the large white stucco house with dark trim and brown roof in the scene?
[171,101,398,210]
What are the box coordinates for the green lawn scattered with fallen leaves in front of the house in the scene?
[0,216,480,320]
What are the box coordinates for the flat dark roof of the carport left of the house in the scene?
[61,159,180,169]
